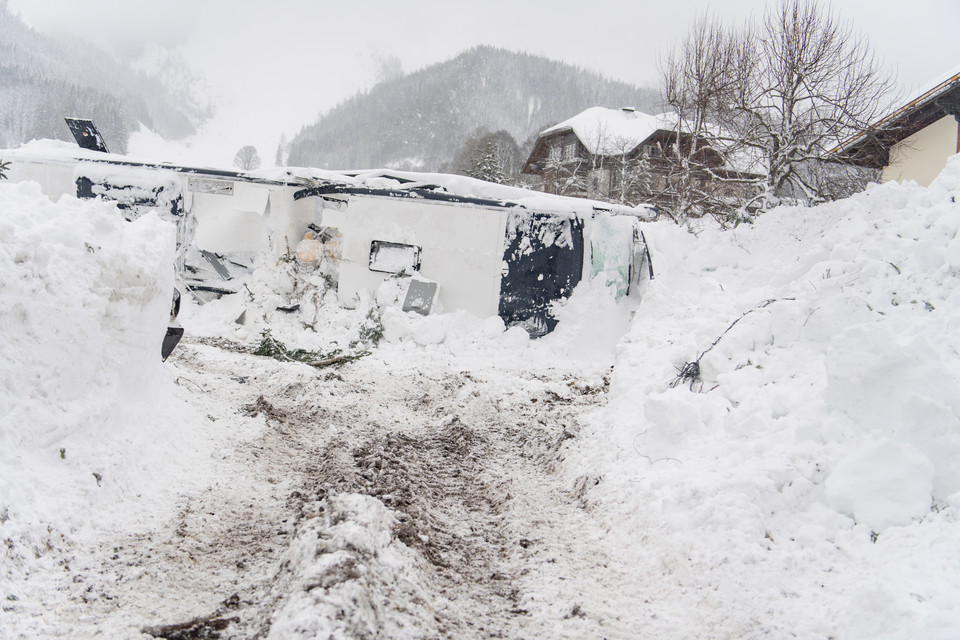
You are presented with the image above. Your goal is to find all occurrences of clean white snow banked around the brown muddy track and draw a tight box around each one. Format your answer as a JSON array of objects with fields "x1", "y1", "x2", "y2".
[{"x1": 0, "y1": 156, "x2": 960, "y2": 639}]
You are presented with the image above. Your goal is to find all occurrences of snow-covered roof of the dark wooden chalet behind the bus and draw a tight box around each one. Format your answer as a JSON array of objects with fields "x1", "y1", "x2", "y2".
[{"x1": 540, "y1": 107, "x2": 677, "y2": 156}]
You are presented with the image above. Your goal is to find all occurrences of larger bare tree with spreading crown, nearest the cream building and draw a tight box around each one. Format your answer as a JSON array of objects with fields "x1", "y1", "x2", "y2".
[{"x1": 734, "y1": 0, "x2": 892, "y2": 201}]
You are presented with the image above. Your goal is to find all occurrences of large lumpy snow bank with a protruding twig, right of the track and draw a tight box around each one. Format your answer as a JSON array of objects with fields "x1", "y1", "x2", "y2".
[{"x1": 568, "y1": 156, "x2": 960, "y2": 640}]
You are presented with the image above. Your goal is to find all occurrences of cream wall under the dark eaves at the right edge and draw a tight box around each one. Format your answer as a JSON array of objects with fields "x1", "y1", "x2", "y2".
[{"x1": 882, "y1": 116, "x2": 960, "y2": 186}]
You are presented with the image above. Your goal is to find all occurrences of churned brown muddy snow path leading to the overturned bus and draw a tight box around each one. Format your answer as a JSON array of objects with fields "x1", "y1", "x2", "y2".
[{"x1": 22, "y1": 343, "x2": 639, "y2": 639}]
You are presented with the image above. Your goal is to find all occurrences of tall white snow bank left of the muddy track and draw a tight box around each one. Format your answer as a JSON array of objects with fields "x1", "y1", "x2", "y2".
[{"x1": 0, "y1": 182, "x2": 211, "y2": 576}]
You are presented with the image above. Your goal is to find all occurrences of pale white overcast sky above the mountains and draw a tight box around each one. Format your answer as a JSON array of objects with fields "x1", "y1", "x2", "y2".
[{"x1": 8, "y1": 0, "x2": 960, "y2": 165}]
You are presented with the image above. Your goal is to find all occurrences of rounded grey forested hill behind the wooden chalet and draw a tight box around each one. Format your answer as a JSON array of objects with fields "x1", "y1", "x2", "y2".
[{"x1": 287, "y1": 47, "x2": 658, "y2": 171}]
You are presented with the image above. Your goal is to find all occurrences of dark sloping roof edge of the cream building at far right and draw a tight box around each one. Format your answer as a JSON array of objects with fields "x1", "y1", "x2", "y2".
[{"x1": 834, "y1": 65, "x2": 960, "y2": 169}]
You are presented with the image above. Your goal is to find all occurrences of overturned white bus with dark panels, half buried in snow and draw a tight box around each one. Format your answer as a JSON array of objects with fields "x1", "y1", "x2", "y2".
[{"x1": 0, "y1": 120, "x2": 655, "y2": 336}]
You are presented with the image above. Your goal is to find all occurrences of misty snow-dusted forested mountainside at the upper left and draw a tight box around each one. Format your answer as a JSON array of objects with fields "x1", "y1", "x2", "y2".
[{"x1": 0, "y1": 0, "x2": 203, "y2": 153}]
